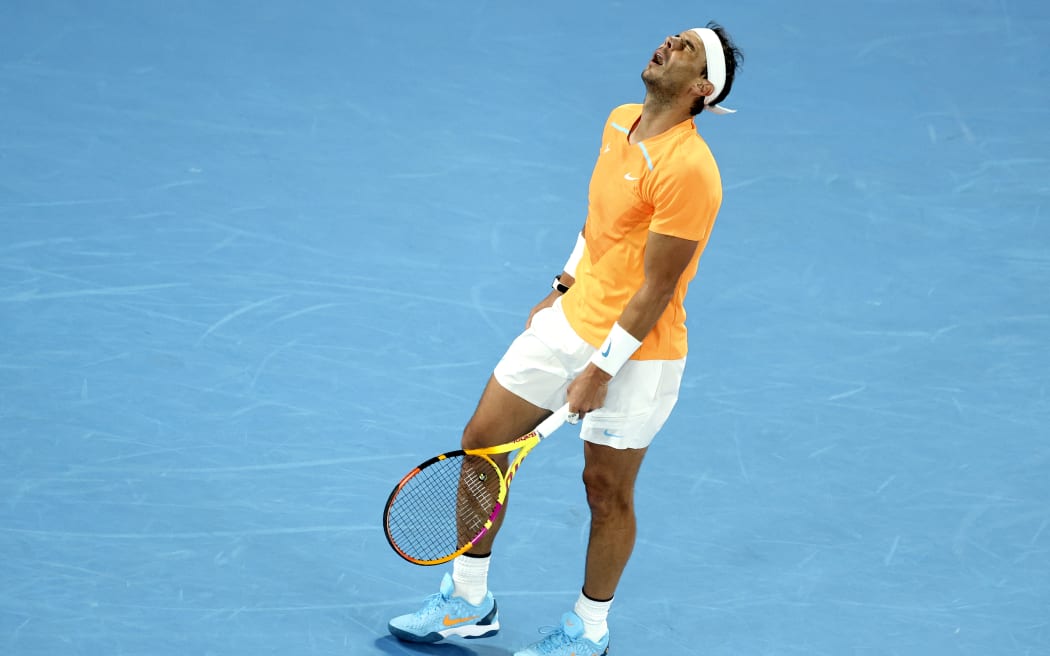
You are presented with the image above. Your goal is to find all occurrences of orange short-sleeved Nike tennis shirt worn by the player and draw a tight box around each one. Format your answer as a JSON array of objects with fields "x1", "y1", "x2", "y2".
[{"x1": 562, "y1": 105, "x2": 722, "y2": 360}]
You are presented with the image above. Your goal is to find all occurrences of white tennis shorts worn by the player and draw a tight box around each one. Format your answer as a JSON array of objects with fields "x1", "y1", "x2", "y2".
[{"x1": 495, "y1": 299, "x2": 686, "y2": 449}]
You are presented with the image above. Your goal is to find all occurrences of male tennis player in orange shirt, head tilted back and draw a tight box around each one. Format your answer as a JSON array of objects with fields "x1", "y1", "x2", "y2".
[{"x1": 390, "y1": 23, "x2": 741, "y2": 656}]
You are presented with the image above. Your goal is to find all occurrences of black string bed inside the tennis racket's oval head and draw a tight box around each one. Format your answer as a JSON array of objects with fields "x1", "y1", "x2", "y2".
[{"x1": 386, "y1": 453, "x2": 501, "y2": 560}]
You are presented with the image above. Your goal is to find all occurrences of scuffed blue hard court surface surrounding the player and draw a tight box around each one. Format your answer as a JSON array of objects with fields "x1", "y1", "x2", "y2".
[{"x1": 0, "y1": 0, "x2": 1050, "y2": 656}]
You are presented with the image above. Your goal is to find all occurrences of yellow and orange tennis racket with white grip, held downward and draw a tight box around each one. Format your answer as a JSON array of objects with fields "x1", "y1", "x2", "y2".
[{"x1": 383, "y1": 404, "x2": 569, "y2": 565}]
